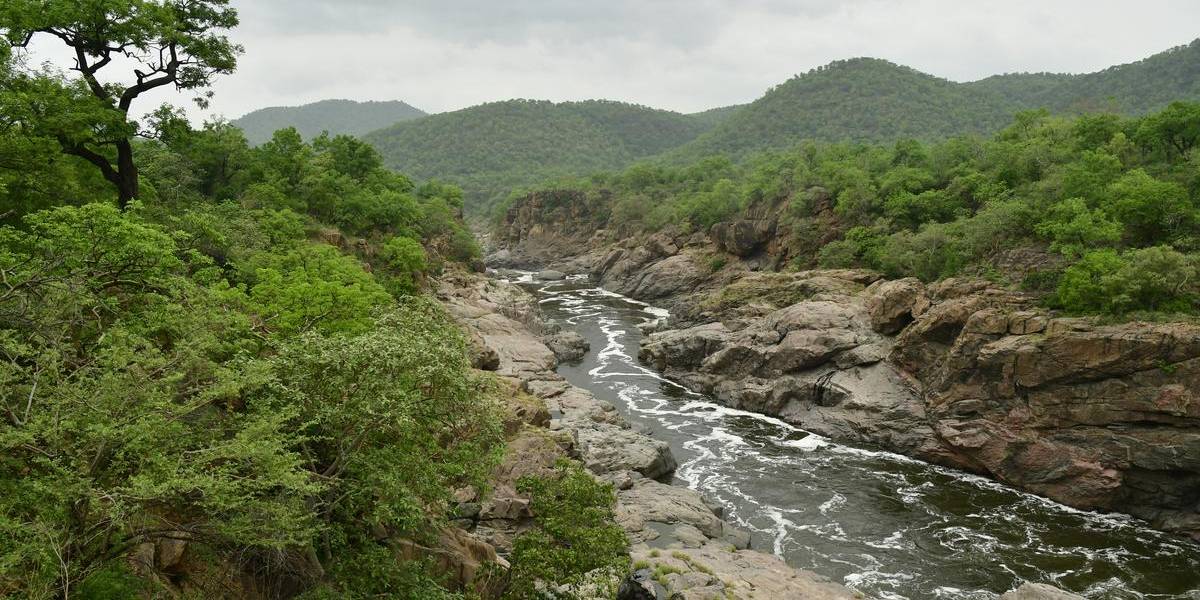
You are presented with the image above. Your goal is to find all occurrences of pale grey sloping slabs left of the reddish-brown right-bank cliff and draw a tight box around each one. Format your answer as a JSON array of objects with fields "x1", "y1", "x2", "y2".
[{"x1": 641, "y1": 272, "x2": 962, "y2": 466}]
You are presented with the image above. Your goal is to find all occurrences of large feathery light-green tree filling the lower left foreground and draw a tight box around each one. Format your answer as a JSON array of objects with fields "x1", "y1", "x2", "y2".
[{"x1": 0, "y1": 204, "x2": 322, "y2": 599}]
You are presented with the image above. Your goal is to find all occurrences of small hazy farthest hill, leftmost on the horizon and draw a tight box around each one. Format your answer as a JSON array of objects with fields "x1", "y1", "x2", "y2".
[{"x1": 233, "y1": 100, "x2": 425, "y2": 145}]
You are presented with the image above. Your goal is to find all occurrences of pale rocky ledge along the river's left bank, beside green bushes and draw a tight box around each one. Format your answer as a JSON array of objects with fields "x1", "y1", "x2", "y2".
[{"x1": 431, "y1": 276, "x2": 854, "y2": 600}]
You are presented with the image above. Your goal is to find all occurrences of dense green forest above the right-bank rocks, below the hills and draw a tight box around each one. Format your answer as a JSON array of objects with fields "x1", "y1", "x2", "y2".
[{"x1": 510, "y1": 102, "x2": 1200, "y2": 316}]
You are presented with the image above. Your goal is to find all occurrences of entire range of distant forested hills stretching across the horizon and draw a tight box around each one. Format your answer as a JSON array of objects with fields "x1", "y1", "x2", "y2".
[{"x1": 235, "y1": 40, "x2": 1200, "y2": 214}]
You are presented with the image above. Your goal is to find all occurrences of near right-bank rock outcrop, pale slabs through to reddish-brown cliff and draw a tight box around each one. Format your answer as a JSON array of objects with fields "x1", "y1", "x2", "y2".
[{"x1": 641, "y1": 270, "x2": 1200, "y2": 535}]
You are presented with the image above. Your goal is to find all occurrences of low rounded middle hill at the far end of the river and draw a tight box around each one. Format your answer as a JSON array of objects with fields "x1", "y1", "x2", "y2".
[{"x1": 365, "y1": 100, "x2": 713, "y2": 210}]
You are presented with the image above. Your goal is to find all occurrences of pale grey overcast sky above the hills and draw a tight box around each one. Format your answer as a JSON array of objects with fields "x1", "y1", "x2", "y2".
[{"x1": 21, "y1": 0, "x2": 1200, "y2": 118}]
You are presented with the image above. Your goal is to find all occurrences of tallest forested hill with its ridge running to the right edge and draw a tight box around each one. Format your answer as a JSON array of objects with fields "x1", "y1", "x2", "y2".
[{"x1": 670, "y1": 40, "x2": 1200, "y2": 161}]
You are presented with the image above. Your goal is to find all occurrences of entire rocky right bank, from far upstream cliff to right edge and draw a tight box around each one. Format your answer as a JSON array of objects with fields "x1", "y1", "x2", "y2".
[{"x1": 484, "y1": 195, "x2": 1200, "y2": 539}]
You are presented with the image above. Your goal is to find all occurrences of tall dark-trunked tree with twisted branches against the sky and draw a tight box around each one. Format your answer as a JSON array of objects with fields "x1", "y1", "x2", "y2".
[{"x1": 0, "y1": 0, "x2": 241, "y2": 209}]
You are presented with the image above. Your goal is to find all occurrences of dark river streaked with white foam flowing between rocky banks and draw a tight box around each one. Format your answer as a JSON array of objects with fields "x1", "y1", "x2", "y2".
[{"x1": 511, "y1": 276, "x2": 1200, "y2": 600}]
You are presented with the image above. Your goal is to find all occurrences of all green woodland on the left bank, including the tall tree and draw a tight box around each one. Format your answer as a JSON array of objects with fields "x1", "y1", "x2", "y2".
[{"x1": 0, "y1": 0, "x2": 628, "y2": 600}]
